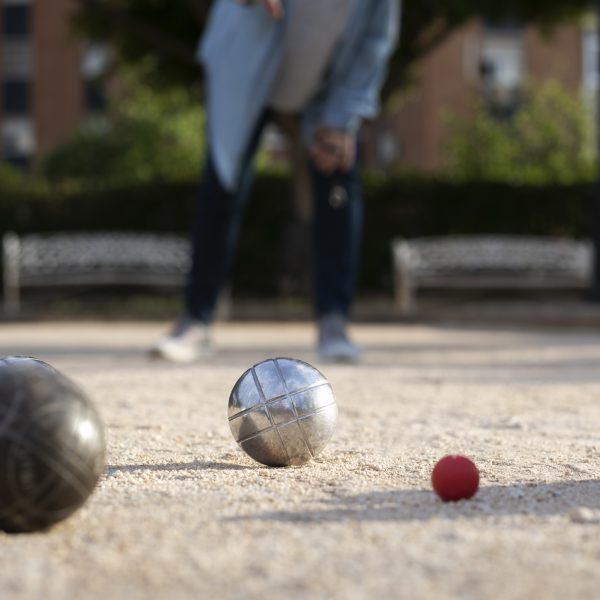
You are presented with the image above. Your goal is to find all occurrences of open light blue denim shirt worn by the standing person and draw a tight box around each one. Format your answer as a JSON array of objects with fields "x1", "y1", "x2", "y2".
[{"x1": 198, "y1": 0, "x2": 400, "y2": 190}]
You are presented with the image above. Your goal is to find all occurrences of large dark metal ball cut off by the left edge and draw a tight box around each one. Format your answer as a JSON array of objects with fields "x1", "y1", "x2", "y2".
[{"x1": 0, "y1": 356, "x2": 106, "y2": 532}]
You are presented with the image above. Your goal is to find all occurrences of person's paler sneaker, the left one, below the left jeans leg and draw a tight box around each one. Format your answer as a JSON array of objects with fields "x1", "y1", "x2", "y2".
[{"x1": 150, "y1": 318, "x2": 213, "y2": 363}]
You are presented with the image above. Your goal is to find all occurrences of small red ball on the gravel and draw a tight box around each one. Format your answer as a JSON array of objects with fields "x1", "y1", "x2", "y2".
[{"x1": 431, "y1": 454, "x2": 479, "y2": 502}]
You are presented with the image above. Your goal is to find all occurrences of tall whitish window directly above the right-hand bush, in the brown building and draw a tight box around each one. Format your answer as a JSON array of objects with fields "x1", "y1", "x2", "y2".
[{"x1": 480, "y1": 26, "x2": 525, "y2": 117}]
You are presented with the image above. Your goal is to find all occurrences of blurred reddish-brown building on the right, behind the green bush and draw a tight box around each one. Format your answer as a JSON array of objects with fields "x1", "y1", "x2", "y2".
[{"x1": 368, "y1": 20, "x2": 598, "y2": 172}]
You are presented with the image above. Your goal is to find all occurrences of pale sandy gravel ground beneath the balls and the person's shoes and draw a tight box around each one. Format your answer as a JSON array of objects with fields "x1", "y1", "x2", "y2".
[{"x1": 0, "y1": 322, "x2": 600, "y2": 600}]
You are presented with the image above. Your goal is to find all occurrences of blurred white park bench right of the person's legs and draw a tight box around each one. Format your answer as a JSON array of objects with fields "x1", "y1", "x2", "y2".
[{"x1": 392, "y1": 235, "x2": 594, "y2": 315}]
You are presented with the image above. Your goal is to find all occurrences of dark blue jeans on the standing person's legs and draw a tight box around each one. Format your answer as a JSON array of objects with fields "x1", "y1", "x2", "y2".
[{"x1": 185, "y1": 114, "x2": 363, "y2": 323}]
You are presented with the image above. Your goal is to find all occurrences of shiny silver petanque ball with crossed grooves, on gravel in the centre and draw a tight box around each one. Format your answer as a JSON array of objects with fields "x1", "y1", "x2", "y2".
[{"x1": 229, "y1": 358, "x2": 337, "y2": 467}]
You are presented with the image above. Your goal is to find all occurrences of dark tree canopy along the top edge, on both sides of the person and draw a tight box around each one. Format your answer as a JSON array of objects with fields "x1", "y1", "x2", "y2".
[{"x1": 76, "y1": 0, "x2": 593, "y2": 89}]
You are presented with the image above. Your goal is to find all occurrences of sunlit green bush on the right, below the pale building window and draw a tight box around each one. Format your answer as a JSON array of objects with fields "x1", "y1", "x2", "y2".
[{"x1": 448, "y1": 81, "x2": 595, "y2": 185}]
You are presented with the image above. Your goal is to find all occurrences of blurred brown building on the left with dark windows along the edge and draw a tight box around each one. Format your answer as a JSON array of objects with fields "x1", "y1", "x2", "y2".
[{"x1": 0, "y1": 0, "x2": 102, "y2": 165}]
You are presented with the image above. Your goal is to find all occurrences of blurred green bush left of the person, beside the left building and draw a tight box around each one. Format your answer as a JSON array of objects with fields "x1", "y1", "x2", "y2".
[{"x1": 42, "y1": 71, "x2": 204, "y2": 189}]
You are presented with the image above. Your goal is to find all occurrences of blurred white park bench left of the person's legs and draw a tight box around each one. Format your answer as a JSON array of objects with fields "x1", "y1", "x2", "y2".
[{"x1": 2, "y1": 232, "x2": 190, "y2": 316}]
